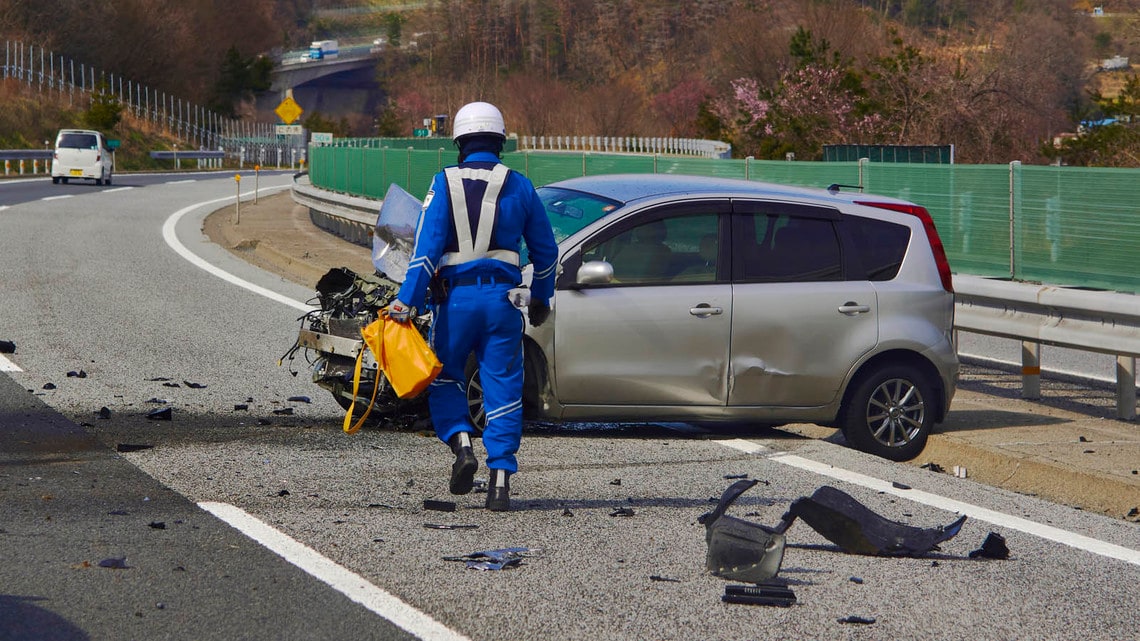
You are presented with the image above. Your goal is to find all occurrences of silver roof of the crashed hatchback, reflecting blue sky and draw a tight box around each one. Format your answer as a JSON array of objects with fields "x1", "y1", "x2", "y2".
[{"x1": 546, "y1": 173, "x2": 907, "y2": 204}]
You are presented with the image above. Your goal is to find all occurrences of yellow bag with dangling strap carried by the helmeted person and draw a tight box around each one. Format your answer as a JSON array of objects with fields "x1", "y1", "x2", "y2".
[{"x1": 344, "y1": 311, "x2": 443, "y2": 433}]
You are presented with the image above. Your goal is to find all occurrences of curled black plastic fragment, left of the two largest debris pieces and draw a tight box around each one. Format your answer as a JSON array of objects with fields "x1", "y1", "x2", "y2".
[{"x1": 700, "y1": 479, "x2": 784, "y2": 583}]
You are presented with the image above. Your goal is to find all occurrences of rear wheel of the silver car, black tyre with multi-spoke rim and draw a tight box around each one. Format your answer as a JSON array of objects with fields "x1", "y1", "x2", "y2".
[{"x1": 842, "y1": 365, "x2": 935, "y2": 461}]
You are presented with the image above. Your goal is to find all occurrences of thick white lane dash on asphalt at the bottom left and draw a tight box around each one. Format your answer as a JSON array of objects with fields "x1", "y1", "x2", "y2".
[{"x1": 198, "y1": 501, "x2": 467, "y2": 641}]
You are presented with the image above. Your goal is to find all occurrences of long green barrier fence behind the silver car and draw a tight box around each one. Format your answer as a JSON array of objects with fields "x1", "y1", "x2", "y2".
[{"x1": 309, "y1": 141, "x2": 1140, "y2": 293}]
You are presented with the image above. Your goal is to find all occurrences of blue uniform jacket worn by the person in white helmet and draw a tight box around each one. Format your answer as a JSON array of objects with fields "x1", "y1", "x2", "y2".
[{"x1": 399, "y1": 152, "x2": 559, "y2": 309}]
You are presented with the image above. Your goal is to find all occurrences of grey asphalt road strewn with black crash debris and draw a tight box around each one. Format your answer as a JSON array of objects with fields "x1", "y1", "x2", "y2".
[{"x1": 0, "y1": 175, "x2": 1140, "y2": 641}]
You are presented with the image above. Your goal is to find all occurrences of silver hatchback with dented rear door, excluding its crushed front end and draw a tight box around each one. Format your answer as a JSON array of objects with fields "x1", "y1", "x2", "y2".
[{"x1": 469, "y1": 175, "x2": 959, "y2": 461}]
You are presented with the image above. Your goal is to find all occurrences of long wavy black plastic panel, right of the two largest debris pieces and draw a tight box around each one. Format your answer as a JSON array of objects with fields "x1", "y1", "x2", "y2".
[{"x1": 780, "y1": 486, "x2": 966, "y2": 557}]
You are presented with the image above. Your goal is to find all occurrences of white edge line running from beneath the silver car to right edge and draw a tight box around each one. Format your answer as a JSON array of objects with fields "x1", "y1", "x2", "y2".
[{"x1": 717, "y1": 439, "x2": 1140, "y2": 566}]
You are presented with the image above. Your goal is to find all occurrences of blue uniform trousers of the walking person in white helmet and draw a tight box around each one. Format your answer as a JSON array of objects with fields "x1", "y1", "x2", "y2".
[{"x1": 428, "y1": 282, "x2": 523, "y2": 473}]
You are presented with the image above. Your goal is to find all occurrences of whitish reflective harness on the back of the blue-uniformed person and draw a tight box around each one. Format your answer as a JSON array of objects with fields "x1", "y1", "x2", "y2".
[{"x1": 440, "y1": 164, "x2": 519, "y2": 267}]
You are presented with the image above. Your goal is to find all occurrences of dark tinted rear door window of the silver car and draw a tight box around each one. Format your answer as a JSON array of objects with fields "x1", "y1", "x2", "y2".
[{"x1": 736, "y1": 213, "x2": 842, "y2": 283}]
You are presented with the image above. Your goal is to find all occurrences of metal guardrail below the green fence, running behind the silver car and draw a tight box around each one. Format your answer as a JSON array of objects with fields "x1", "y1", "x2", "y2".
[{"x1": 293, "y1": 175, "x2": 1140, "y2": 421}]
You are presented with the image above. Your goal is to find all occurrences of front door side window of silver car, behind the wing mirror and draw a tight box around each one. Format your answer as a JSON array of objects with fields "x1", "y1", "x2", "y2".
[{"x1": 583, "y1": 213, "x2": 719, "y2": 285}]
